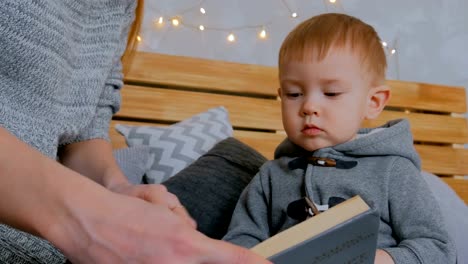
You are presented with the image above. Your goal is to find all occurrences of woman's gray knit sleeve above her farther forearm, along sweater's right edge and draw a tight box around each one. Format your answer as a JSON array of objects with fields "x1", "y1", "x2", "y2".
[{"x1": 75, "y1": 1, "x2": 136, "y2": 142}]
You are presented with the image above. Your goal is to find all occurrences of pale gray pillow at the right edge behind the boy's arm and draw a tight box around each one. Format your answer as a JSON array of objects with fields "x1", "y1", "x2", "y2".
[{"x1": 421, "y1": 171, "x2": 468, "y2": 263}]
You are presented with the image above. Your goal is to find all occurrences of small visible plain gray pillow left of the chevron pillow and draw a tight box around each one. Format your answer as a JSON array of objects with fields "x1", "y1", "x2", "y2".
[{"x1": 114, "y1": 146, "x2": 150, "y2": 184}]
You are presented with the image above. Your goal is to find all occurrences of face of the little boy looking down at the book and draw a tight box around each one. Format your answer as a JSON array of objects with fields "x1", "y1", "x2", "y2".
[{"x1": 278, "y1": 47, "x2": 370, "y2": 151}]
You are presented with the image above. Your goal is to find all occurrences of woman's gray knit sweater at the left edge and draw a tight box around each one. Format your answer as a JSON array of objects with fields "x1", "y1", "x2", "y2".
[{"x1": 0, "y1": 0, "x2": 136, "y2": 263}]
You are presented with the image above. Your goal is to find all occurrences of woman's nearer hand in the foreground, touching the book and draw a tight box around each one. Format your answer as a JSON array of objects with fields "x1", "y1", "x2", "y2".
[{"x1": 48, "y1": 186, "x2": 269, "y2": 264}]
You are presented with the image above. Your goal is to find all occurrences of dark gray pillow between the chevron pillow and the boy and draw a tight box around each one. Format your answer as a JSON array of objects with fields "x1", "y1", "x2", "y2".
[{"x1": 162, "y1": 137, "x2": 266, "y2": 239}]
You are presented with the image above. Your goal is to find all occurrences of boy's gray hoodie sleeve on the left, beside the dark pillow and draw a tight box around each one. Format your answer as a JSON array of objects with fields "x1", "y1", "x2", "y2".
[{"x1": 223, "y1": 166, "x2": 270, "y2": 248}]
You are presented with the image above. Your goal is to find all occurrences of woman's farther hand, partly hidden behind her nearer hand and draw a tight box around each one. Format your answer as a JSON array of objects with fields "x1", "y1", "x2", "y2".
[{"x1": 109, "y1": 182, "x2": 197, "y2": 228}]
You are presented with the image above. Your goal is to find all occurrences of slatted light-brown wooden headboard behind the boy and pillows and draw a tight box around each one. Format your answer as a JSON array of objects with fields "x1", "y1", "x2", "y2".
[{"x1": 110, "y1": 52, "x2": 468, "y2": 203}]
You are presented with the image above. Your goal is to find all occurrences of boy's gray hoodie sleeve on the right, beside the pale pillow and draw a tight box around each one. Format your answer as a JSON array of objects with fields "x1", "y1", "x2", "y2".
[{"x1": 383, "y1": 159, "x2": 456, "y2": 263}]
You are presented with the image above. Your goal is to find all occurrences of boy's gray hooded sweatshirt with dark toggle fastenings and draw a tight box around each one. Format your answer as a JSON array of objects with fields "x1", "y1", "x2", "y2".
[{"x1": 223, "y1": 120, "x2": 456, "y2": 264}]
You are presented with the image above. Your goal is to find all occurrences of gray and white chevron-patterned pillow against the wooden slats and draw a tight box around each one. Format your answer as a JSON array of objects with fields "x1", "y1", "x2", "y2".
[{"x1": 116, "y1": 106, "x2": 232, "y2": 183}]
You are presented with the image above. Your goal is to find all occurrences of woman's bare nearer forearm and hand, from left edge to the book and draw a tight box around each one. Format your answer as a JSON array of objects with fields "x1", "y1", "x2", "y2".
[{"x1": 0, "y1": 127, "x2": 267, "y2": 264}]
